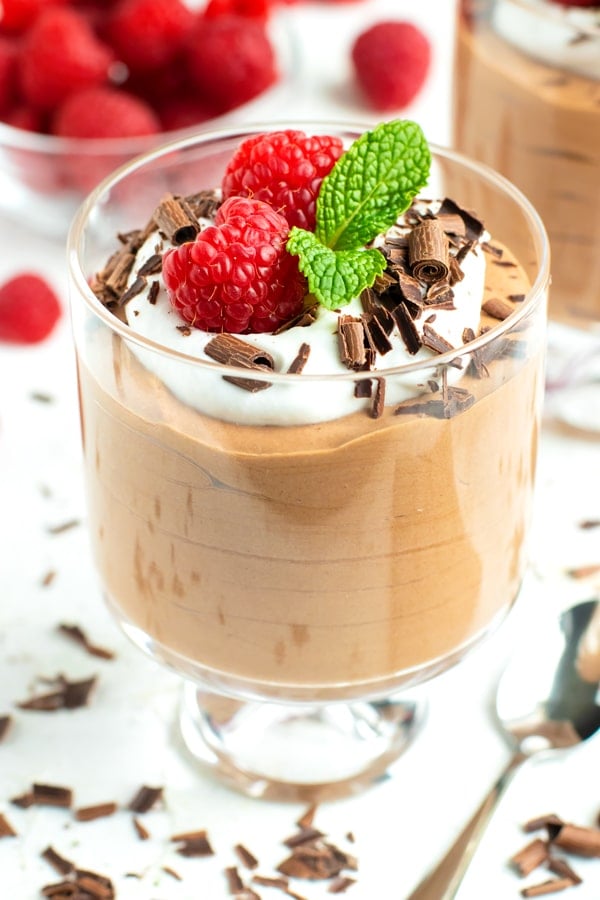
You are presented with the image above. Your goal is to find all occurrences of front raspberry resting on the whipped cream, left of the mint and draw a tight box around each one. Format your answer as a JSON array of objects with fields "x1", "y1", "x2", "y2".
[{"x1": 163, "y1": 197, "x2": 306, "y2": 334}]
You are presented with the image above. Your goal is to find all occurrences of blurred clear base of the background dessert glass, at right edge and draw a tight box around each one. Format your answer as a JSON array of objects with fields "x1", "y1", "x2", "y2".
[{"x1": 546, "y1": 322, "x2": 600, "y2": 437}]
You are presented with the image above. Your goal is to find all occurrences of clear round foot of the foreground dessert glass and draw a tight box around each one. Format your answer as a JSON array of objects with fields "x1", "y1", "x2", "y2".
[{"x1": 180, "y1": 682, "x2": 425, "y2": 803}]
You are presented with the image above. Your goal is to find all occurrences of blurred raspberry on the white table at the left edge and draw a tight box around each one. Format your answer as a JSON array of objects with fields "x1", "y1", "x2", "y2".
[{"x1": 0, "y1": 272, "x2": 61, "y2": 344}]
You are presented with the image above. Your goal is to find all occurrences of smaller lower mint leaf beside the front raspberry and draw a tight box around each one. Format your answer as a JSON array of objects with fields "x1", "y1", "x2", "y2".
[{"x1": 287, "y1": 227, "x2": 386, "y2": 309}]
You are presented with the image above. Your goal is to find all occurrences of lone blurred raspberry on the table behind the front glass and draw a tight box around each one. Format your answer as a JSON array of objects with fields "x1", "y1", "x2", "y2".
[{"x1": 352, "y1": 22, "x2": 431, "y2": 110}]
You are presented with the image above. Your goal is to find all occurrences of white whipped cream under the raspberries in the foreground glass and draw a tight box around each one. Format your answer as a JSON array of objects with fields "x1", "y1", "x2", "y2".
[{"x1": 119, "y1": 206, "x2": 487, "y2": 425}]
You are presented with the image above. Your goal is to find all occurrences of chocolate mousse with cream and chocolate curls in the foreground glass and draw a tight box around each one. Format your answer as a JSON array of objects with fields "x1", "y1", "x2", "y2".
[{"x1": 71, "y1": 125, "x2": 544, "y2": 699}]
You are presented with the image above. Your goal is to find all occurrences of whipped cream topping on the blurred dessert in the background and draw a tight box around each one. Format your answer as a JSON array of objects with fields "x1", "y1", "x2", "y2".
[{"x1": 492, "y1": 0, "x2": 600, "y2": 80}]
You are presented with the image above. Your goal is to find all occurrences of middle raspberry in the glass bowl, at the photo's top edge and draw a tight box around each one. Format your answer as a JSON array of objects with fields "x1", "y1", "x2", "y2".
[{"x1": 106, "y1": 0, "x2": 196, "y2": 72}]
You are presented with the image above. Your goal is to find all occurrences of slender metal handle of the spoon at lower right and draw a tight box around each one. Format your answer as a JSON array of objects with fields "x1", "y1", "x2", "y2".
[{"x1": 408, "y1": 752, "x2": 527, "y2": 900}]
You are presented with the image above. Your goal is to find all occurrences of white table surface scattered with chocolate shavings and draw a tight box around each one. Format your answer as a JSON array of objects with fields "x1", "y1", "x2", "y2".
[{"x1": 0, "y1": 0, "x2": 600, "y2": 900}]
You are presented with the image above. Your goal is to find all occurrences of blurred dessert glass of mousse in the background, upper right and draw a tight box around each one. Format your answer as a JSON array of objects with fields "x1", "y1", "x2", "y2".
[{"x1": 453, "y1": 0, "x2": 600, "y2": 434}]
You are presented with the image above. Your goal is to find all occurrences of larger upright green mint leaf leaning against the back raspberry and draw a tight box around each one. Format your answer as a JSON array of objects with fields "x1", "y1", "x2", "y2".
[{"x1": 316, "y1": 119, "x2": 431, "y2": 250}]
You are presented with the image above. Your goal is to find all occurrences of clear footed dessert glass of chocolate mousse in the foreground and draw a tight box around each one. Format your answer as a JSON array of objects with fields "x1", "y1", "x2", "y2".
[{"x1": 68, "y1": 123, "x2": 549, "y2": 799}]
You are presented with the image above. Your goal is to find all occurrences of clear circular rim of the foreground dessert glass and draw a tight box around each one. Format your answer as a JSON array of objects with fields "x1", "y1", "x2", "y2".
[{"x1": 67, "y1": 119, "x2": 550, "y2": 384}]
